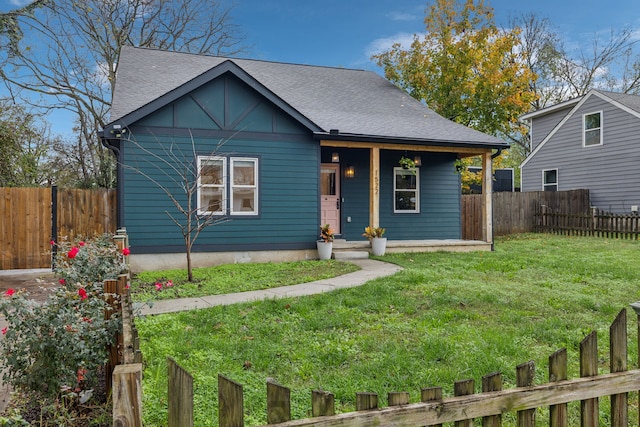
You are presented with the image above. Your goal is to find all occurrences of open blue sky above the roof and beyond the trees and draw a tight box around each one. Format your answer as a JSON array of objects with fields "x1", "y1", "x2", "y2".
[{"x1": 0, "y1": 0, "x2": 640, "y2": 134}]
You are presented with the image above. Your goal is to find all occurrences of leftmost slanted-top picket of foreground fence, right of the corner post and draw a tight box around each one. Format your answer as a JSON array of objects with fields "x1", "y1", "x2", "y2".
[{"x1": 167, "y1": 357, "x2": 193, "y2": 427}]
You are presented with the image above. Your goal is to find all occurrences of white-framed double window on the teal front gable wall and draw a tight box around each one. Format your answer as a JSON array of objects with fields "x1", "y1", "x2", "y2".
[{"x1": 198, "y1": 156, "x2": 258, "y2": 215}]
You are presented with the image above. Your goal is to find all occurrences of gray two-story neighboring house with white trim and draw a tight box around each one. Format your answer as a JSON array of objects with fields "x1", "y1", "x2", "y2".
[{"x1": 520, "y1": 90, "x2": 640, "y2": 213}]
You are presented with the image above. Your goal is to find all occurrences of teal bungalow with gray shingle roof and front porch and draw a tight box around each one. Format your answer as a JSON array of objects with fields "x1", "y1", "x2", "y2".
[{"x1": 102, "y1": 47, "x2": 508, "y2": 268}]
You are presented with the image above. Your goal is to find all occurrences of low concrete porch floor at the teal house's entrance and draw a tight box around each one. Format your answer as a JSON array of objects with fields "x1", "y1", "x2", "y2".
[{"x1": 333, "y1": 239, "x2": 491, "y2": 253}]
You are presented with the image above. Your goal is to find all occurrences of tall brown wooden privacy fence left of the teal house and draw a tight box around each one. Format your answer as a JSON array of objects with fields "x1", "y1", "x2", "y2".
[{"x1": 0, "y1": 187, "x2": 116, "y2": 270}]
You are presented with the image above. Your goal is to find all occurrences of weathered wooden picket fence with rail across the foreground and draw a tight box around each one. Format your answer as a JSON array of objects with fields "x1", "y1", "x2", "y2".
[{"x1": 158, "y1": 307, "x2": 640, "y2": 427}]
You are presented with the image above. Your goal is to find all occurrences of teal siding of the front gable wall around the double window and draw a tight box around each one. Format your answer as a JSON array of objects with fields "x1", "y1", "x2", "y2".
[{"x1": 122, "y1": 72, "x2": 320, "y2": 253}]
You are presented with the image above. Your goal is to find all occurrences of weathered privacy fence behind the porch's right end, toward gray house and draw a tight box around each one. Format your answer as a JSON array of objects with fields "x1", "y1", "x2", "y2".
[{"x1": 462, "y1": 190, "x2": 590, "y2": 240}]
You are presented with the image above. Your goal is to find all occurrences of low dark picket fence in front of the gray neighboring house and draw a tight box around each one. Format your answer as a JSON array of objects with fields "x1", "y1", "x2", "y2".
[{"x1": 534, "y1": 206, "x2": 640, "y2": 240}]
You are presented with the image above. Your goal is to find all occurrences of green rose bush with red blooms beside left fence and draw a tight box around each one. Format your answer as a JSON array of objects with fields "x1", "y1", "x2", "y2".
[{"x1": 0, "y1": 236, "x2": 124, "y2": 398}]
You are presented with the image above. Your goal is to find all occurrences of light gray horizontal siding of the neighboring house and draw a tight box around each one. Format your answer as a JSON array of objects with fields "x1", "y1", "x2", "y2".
[{"x1": 522, "y1": 96, "x2": 640, "y2": 213}]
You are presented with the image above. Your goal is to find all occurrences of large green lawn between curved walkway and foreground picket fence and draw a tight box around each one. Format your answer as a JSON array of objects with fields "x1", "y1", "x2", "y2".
[{"x1": 137, "y1": 235, "x2": 640, "y2": 426}]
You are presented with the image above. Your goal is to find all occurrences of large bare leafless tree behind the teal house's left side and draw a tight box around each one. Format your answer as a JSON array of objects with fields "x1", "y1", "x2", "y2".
[{"x1": 0, "y1": 0, "x2": 243, "y2": 186}]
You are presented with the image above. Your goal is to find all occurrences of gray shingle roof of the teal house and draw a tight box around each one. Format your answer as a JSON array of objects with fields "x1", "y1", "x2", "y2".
[{"x1": 111, "y1": 47, "x2": 508, "y2": 148}]
